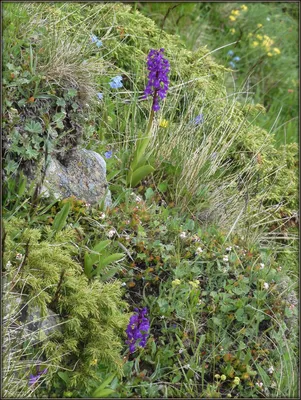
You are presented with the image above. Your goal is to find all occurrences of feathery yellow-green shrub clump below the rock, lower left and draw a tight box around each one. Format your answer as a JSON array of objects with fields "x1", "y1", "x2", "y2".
[{"x1": 4, "y1": 218, "x2": 129, "y2": 396}]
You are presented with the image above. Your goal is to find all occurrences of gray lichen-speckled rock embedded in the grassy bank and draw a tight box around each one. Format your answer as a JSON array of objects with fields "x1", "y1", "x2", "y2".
[{"x1": 40, "y1": 149, "x2": 112, "y2": 207}]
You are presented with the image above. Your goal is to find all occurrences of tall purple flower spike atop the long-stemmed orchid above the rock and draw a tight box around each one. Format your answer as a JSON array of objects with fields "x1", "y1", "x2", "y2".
[{"x1": 144, "y1": 49, "x2": 170, "y2": 111}]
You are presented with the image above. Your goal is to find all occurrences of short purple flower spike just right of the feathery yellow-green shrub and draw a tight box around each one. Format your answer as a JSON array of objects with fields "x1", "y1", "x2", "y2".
[{"x1": 126, "y1": 307, "x2": 149, "y2": 353}]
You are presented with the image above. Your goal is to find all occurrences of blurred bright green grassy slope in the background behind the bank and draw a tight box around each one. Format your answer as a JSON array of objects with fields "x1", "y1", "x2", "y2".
[{"x1": 140, "y1": 3, "x2": 299, "y2": 143}]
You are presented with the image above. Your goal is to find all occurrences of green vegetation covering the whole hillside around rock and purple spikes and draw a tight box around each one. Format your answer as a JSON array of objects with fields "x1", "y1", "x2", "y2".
[{"x1": 2, "y1": 3, "x2": 298, "y2": 398}]
